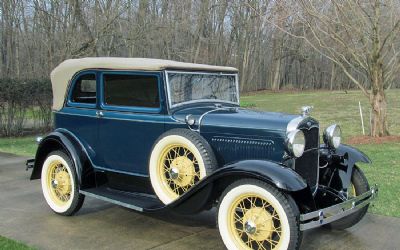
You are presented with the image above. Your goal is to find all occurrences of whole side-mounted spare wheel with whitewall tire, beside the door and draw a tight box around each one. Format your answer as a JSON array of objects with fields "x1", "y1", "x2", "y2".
[{"x1": 149, "y1": 129, "x2": 217, "y2": 204}]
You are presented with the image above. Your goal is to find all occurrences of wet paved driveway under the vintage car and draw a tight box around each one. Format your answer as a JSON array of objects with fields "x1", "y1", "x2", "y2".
[{"x1": 0, "y1": 153, "x2": 400, "y2": 250}]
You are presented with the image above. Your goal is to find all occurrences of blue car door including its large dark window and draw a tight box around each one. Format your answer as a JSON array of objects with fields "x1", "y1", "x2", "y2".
[{"x1": 99, "y1": 71, "x2": 165, "y2": 176}]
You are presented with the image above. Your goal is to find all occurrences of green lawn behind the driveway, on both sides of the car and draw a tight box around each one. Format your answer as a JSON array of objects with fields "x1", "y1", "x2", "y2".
[{"x1": 0, "y1": 90, "x2": 400, "y2": 221}]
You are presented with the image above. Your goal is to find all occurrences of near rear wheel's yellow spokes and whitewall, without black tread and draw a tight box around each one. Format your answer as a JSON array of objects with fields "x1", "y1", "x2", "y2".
[{"x1": 41, "y1": 151, "x2": 76, "y2": 213}]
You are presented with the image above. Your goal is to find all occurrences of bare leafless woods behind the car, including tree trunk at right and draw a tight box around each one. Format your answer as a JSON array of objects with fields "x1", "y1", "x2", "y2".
[{"x1": 0, "y1": 0, "x2": 400, "y2": 136}]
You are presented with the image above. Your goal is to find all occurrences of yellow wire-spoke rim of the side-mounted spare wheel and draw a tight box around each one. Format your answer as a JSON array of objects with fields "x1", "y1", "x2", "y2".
[{"x1": 158, "y1": 144, "x2": 201, "y2": 198}]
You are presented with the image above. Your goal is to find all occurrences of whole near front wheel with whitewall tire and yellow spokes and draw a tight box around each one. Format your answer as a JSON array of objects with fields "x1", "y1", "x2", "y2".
[{"x1": 217, "y1": 179, "x2": 301, "y2": 250}]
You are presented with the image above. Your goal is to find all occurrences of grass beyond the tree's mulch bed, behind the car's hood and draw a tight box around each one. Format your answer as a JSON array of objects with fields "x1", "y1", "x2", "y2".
[{"x1": 241, "y1": 89, "x2": 400, "y2": 139}]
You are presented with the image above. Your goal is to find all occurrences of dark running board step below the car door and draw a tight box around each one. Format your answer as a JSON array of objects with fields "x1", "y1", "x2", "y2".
[{"x1": 79, "y1": 186, "x2": 165, "y2": 212}]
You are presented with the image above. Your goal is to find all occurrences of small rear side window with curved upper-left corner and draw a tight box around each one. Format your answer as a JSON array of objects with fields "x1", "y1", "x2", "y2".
[{"x1": 71, "y1": 74, "x2": 96, "y2": 104}]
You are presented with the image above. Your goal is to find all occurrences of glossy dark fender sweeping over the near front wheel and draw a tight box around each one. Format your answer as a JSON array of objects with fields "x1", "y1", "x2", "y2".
[{"x1": 168, "y1": 160, "x2": 308, "y2": 213}]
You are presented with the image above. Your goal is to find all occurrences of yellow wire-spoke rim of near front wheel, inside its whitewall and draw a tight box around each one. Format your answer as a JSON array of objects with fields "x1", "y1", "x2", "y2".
[{"x1": 228, "y1": 193, "x2": 282, "y2": 249}]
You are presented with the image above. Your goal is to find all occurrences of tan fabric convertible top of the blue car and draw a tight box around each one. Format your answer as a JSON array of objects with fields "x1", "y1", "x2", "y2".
[{"x1": 50, "y1": 57, "x2": 238, "y2": 110}]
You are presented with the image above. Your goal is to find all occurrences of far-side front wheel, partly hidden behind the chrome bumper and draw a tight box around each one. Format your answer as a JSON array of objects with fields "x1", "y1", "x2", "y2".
[{"x1": 325, "y1": 166, "x2": 369, "y2": 230}]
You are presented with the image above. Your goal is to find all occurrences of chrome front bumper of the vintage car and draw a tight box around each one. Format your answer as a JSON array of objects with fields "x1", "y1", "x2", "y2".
[{"x1": 300, "y1": 185, "x2": 378, "y2": 231}]
